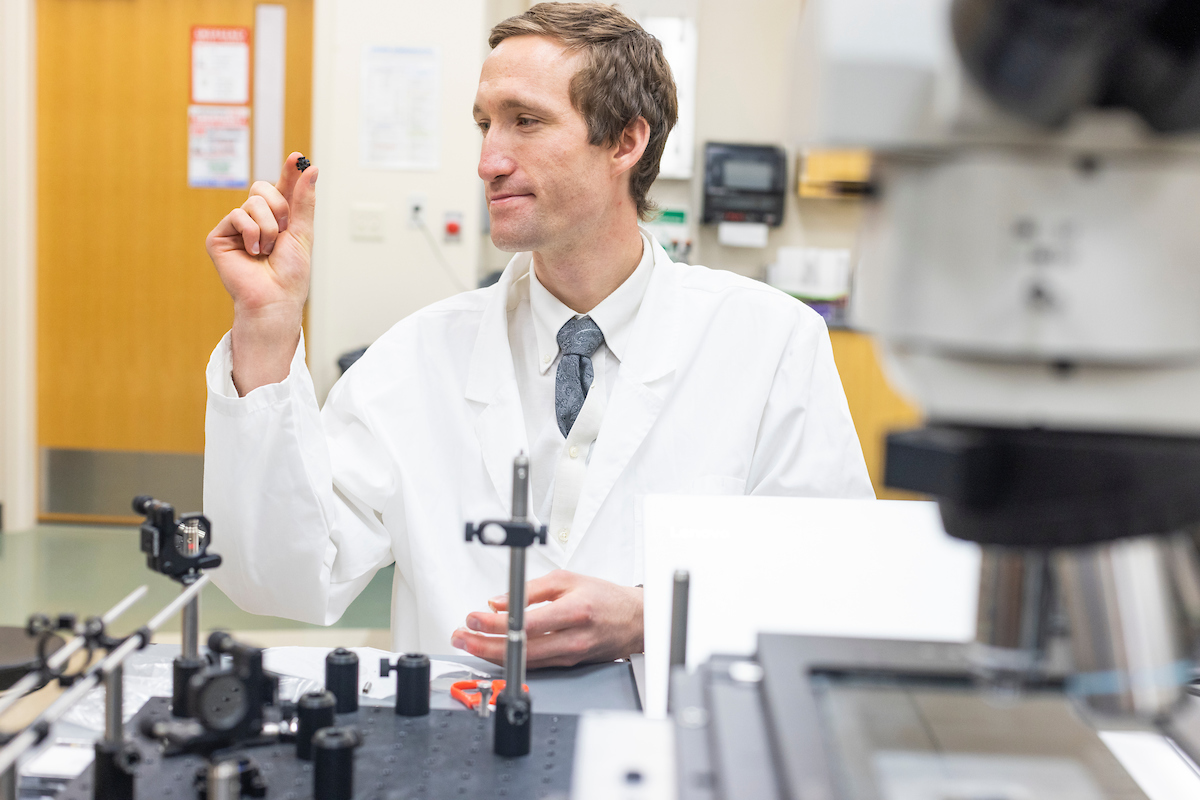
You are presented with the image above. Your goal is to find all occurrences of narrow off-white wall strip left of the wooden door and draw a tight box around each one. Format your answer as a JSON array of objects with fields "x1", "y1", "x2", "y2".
[{"x1": 0, "y1": 0, "x2": 37, "y2": 530}]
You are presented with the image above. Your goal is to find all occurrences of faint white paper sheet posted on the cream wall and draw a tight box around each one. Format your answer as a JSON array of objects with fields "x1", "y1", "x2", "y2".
[{"x1": 359, "y1": 47, "x2": 442, "y2": 170}]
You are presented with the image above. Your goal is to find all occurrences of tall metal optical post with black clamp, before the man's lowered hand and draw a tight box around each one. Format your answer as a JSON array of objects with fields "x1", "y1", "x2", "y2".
[{"x1": 467, "y1": 453, "x2": 547, "y2": 756}]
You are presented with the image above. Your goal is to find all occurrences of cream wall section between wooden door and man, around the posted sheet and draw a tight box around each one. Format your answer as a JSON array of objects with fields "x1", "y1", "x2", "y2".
[{"x1": 308, "y1": 0, "x2": 485, "y2": 398}]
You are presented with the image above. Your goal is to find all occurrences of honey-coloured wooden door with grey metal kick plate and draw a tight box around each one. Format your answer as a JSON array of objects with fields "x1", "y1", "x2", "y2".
[{"x1": 37, "y1": 0, "x2": 312, "y2": 521}]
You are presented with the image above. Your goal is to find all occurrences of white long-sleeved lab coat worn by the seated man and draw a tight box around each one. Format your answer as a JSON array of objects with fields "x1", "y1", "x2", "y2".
[{"x1": 204, "y1": 236, "x2": 874, "y2": 652}]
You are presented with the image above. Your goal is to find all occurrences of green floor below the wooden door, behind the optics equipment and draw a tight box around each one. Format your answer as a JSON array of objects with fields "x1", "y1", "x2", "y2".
[{"x1": 0, "y1": 525, "x2": 392, "y2": 633}]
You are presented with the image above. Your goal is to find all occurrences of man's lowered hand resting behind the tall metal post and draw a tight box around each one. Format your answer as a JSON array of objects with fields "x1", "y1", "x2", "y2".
[{"x1": 450, "y1": 570, "x2": 642, "y2": 669}]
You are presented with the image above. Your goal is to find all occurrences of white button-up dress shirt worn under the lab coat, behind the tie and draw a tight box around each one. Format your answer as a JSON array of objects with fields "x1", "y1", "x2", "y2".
[{"x1": 508, "y1": 232, "x2": 654, "y2": 545}]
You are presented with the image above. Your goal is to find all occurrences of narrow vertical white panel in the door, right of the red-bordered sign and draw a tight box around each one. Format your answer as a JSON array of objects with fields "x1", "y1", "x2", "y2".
[{"x1": 251, "y1": 4, "x2": 288, "y2": 184}]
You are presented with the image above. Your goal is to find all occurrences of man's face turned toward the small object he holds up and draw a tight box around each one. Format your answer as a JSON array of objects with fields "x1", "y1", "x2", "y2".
[{"x1": 474, "y1": 36, "x2": 619, "y2": 252}]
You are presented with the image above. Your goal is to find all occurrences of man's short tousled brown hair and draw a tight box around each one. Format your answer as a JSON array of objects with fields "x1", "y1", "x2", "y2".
[{"x1": 487, "y1": 2, "x2": 679, "y2": 219}]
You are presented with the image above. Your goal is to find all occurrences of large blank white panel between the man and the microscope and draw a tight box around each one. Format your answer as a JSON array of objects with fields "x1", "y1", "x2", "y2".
[{"x1": 642, "y1": 495, "x2": 979, "y2": 715}]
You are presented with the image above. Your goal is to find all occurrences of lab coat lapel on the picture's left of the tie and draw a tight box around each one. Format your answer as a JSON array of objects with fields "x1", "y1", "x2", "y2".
[{"x1": 466, "y1": 253, "x2": 529, "y2": 520}]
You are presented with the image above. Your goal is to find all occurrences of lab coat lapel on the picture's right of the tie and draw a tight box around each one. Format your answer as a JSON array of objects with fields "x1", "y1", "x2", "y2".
[{"x1": 569, "y1": 242, "x2": 679, "y2": 552}]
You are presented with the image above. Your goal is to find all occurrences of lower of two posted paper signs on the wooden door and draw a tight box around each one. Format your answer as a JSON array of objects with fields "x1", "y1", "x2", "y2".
[{"x1": 187, "y1": 106, "x2": 250, "y2": 188}]
